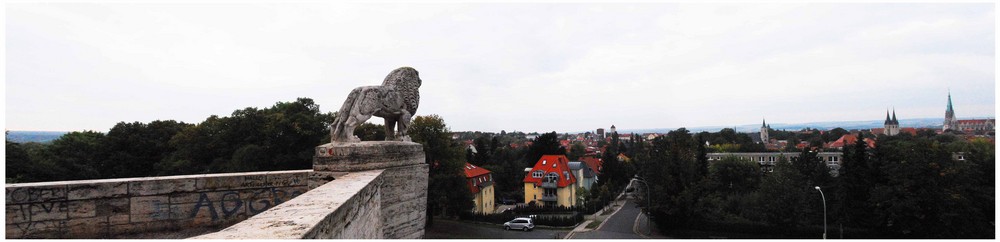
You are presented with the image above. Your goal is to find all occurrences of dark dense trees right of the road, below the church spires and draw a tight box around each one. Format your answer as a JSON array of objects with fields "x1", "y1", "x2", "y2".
[{"x1": 631, "y1": 129, "x2": 995, "y2": 238}]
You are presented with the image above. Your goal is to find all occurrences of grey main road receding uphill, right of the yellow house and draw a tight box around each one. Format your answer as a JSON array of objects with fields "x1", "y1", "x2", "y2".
[{"x1": 571, "y1": 199, "x2": 643, "y2": 239}]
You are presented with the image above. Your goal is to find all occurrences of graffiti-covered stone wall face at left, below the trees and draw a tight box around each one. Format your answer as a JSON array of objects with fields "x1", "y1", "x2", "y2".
[{"x1": 5, "y1": 170, "x2": 312, "y2": 239}]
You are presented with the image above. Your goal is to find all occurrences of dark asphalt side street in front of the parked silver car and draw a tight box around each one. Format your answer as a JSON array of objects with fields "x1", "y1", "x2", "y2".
[{"x1": 424, "y1": 216, "x2": 576, "y2": 239}]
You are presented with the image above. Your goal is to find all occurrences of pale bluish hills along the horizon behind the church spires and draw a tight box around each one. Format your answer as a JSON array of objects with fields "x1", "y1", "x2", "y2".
[{"x1": 608, "y1": 117, "x2": 992, "y2": 134}]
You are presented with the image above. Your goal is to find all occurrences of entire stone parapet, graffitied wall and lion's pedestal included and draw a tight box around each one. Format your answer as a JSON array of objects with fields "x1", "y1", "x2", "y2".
[{"x1": 6, "y1": 142, "x2": 429, "y2": 239}]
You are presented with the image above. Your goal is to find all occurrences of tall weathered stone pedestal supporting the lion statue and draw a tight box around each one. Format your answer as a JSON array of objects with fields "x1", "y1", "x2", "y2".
[{"x1": 309, "y1": 141, "x2": 428, "y2": 239}]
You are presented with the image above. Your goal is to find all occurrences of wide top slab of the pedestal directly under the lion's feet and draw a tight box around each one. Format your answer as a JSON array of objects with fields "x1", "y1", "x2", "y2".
[{"x1": 313, "y1": 141, "x2": 424, "y2": 172}]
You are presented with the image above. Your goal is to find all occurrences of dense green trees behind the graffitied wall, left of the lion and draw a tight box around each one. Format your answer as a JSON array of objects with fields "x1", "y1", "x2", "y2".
[{"x1": 6, "y1": 98, "x2": 333, "y2": 182}]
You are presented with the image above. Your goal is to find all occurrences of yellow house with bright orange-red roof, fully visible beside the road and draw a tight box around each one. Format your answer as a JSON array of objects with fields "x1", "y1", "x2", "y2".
[{"x1": 524, "y1": 155, "x2": 577, "y2": 207}]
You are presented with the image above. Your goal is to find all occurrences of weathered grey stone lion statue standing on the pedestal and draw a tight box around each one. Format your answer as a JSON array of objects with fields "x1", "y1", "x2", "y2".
[{"x1": 330, "y1": 67, "x2": 422, "y2": 142}]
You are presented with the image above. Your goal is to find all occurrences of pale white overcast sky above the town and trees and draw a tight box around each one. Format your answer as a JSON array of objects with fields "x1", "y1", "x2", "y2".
[{"x1": 5, "y1": 2, "x2": 996, "y2": 132}]
